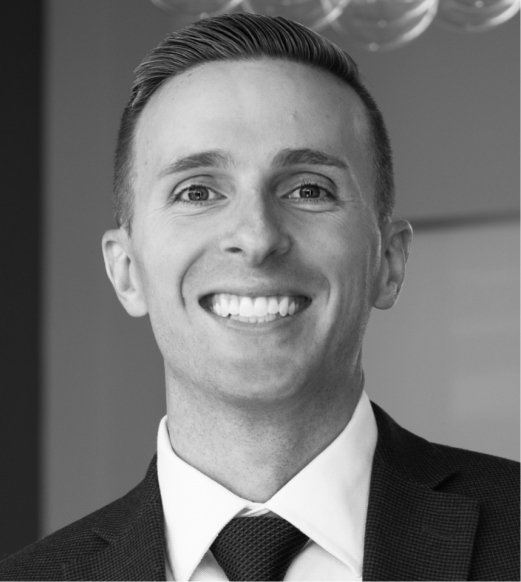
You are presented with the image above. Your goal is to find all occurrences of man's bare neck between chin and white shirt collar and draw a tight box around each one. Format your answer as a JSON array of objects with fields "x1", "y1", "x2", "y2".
[{"x1": 167, "y1": 365, "x2": 363, "y2": 503}]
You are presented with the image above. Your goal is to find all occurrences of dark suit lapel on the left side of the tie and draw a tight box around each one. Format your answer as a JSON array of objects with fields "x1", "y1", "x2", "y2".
[{"x1": 63, "y1": 457, "x2": 165, "y2": 580}]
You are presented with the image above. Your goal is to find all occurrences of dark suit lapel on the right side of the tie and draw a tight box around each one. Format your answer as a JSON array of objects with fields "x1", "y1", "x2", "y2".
[{"x1": 363, "y1": 404, "x2": 479, "y2": 580}]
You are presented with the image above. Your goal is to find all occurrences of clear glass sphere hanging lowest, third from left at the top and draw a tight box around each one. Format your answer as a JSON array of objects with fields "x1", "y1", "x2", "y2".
[{"x1": 331, "y1": 0, "x2": 438, "y2": 51}]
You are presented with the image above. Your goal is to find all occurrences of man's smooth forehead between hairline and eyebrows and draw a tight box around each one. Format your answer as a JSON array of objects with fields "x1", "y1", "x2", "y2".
[{"x1": 134, "y1": 59, "x2": 369, "y2": 187}]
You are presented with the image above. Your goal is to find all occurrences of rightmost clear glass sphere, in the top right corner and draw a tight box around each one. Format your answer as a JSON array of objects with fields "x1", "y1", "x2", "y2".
[{"x1": 437, "y1": 0, "x2": 520, "y2": 32}]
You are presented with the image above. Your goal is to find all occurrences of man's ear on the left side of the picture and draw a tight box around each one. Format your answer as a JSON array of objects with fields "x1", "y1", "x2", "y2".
[{"x1": 102, "y1": 228, "x2": 148, "y2": 317}]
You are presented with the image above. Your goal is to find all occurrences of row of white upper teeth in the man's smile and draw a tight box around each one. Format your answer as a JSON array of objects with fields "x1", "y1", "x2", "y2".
[{"x1": 210, "y1": 293, "x2": 302, "y2": 319}]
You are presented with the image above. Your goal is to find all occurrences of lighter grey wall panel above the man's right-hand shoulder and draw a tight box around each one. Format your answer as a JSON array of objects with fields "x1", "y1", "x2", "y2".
[{"x1": 364, "y1": 221, "x2": 519, "y2": 460}]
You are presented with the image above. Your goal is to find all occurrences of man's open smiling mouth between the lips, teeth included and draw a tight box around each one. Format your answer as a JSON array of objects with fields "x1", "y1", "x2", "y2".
[{"x1": 201, "y1": 293, "x2": 311, "y2": 323}]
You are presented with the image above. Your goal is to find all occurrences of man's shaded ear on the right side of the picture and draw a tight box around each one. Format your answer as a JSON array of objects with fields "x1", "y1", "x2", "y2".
[{"x1": 373, "y1": 220, "x2": 412, "y2": 309}]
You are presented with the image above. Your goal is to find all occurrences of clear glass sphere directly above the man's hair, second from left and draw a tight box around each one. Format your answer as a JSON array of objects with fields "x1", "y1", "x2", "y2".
[{"x1": 242, "y1": 0, "x2": 350, "y2": 30}]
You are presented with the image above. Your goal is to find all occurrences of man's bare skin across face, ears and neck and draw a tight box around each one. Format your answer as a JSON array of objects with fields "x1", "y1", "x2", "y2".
[{"x1": 103, "y1": 59, "x2": 412, "y2": 502}]
